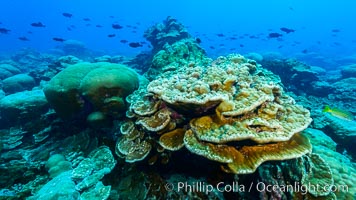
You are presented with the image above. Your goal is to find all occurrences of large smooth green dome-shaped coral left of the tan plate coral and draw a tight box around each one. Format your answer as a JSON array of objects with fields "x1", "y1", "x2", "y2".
[{"x1": 44, "y1": 62, "x2": 138, "y2": 119}]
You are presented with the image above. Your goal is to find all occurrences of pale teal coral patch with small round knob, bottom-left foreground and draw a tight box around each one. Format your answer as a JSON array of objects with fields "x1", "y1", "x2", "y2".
[{"x1": 29, "y1": 146, "x2": 116, "y2": 199}]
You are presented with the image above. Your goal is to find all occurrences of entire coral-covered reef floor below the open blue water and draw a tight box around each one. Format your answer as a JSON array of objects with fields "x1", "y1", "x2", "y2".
[{"x1": 0, "y1": 18, "x2": 356, "y2": 200}]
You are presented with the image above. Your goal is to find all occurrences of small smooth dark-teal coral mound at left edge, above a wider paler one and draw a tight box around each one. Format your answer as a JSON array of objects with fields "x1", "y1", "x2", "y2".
[{"x1": 2, "y1": 74, "x2": 35, "y2": 94}]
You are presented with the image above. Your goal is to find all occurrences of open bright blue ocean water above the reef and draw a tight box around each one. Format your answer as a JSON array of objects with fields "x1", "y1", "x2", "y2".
[{"x1": 0, "y1": 0, "x2": 356, "y2": 64}]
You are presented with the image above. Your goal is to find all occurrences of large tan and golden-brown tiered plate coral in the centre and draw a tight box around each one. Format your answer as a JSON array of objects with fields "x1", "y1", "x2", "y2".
[{"x1": 117, "y1": 51, "x2": 311, "y2": 174}]
